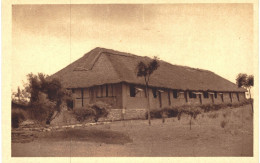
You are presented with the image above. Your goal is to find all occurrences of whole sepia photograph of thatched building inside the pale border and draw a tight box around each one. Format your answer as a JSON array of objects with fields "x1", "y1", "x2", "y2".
[{"x1": 2, "y1": 2, "x2": 258, "y2": 161}]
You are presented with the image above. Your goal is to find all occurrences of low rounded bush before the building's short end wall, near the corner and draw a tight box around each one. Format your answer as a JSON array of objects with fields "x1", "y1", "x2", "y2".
[{"x1": 73, "y1": 102, "x2": 111, "y2": 122}]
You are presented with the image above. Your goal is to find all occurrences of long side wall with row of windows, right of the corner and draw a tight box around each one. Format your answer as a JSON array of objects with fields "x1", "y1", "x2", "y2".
[{"x1": 123, "y1": 83, "x2": 245, "y2": 109}]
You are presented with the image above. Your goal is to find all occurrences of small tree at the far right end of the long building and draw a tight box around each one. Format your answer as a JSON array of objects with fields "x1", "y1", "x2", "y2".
[{"x1": 236, "y1": 73, "x2": 254, "y2": 112}]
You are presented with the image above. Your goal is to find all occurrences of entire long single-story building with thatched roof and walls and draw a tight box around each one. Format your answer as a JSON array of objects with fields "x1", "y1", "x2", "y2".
[{"x1": 52, "y1": 48, "x2": 246, "y2": 118}]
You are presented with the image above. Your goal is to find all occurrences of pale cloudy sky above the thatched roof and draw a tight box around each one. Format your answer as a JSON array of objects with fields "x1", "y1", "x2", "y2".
[{"x1": 12, "y1": 4, "x2": 254, "y2": 90}]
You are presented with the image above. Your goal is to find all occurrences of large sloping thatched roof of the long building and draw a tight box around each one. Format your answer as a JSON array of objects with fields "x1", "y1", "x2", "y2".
[{"x1": 51, "y1": 48, "x2": 246, "y2": 92}]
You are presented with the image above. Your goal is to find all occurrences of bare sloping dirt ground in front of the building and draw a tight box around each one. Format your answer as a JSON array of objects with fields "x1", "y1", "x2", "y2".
[{"x1": 12, "y1": 105, "x2": 253, "y2": 157}]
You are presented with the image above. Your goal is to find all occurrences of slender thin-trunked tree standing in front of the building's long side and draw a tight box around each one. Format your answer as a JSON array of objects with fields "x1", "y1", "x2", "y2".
[{"x1": 136, "y1": 57, "x2": 160, "y2": 125}]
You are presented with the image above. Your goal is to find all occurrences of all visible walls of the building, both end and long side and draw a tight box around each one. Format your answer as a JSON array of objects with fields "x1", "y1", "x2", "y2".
[{"x1": 71, "y1": 83, "x2": 245, "y2": 120}]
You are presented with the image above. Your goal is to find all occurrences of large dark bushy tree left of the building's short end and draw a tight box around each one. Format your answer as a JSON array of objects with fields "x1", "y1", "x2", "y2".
[{"x1": 12, "y1": 73, "x2": 71, "y2": 124}]
